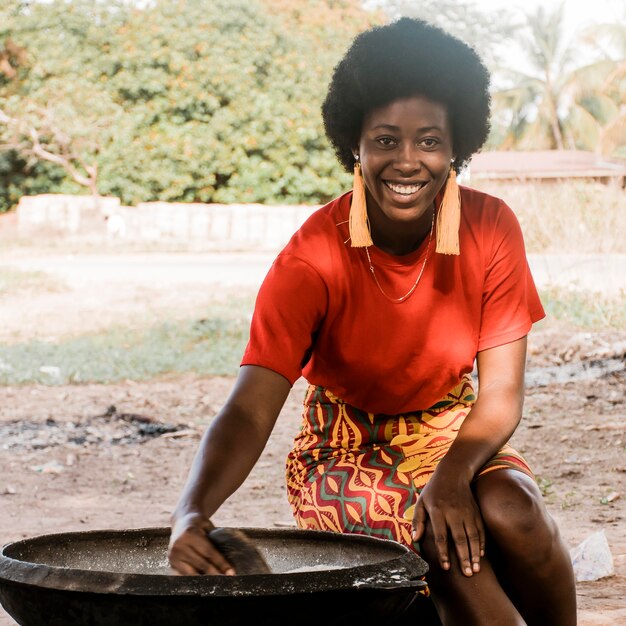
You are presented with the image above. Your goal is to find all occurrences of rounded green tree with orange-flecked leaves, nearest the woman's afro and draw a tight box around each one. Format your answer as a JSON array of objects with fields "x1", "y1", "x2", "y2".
[{"x1": 98, "y1": 0, "x2": 346, "y2": 202}]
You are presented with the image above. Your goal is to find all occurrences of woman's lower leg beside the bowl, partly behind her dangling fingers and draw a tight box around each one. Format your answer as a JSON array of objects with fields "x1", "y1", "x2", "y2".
[{"x1": 420, "y1": 525, "x2": 525, "y2": 626}]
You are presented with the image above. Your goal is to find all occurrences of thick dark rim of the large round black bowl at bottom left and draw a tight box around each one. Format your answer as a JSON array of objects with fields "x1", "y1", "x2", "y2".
[{"x1": 0, "y1": 527, "x2": 428, "y2": 597}]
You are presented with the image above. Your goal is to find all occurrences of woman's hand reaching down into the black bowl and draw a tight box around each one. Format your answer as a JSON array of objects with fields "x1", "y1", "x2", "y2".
[{"x1": 167, "y1": 514, "x2": 236, "y2": 576}]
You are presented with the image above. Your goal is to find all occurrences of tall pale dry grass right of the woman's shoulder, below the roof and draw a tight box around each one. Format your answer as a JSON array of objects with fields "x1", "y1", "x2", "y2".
[{"x1": 472, "y1": 181, "x2": 626, "y2": 254}]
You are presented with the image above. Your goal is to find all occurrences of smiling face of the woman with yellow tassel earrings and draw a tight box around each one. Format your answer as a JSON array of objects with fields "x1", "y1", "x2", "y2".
[{"x1": 358, "y1": 96, "x2": 453, "y2": 235}]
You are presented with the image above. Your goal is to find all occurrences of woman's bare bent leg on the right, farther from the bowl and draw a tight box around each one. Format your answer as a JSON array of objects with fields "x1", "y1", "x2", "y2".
[{"x1": 475, "y1": 469, "x2": 576, "y2": 626}]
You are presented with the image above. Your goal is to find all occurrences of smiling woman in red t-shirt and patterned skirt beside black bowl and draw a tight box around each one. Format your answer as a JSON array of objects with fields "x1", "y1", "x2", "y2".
[{"x1": 169, "y1": 18, "x2": 576, "y2": 626}]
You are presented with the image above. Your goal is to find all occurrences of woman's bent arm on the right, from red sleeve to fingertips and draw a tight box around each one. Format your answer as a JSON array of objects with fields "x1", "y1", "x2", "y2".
[{"x1": 413, "y1": 337, "x2": 526, "y2": 576}]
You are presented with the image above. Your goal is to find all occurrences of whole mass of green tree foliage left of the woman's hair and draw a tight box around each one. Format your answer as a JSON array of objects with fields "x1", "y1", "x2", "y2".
[{"x1": 0, "y1": 0, "x2": 375, "y2": 208}]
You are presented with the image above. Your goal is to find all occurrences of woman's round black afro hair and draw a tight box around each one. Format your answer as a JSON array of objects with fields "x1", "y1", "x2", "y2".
[{"x1": 322, "y1": 17, "x2": 490, "y2": 172}]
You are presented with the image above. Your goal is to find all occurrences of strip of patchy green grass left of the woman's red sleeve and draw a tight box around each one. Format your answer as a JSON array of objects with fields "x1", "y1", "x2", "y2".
[{"x1": 0, "y1": 303, "x2": 254, "y2": 385}]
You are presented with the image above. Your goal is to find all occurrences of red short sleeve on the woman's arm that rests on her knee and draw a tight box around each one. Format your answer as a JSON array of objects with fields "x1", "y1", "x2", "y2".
[{"x1": 478, "y1": 203, "x2": 545, "y2": 351}]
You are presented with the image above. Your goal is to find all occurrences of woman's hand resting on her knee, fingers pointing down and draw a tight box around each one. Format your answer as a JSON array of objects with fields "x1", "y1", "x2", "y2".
[{"x1": 413, "y1": 471, "x2": 485, "y2": 576}]
